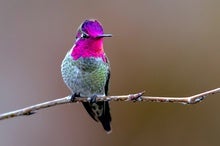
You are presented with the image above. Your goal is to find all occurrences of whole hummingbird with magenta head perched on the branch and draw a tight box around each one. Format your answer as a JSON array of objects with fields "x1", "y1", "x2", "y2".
[{"x1": 61, "y1": 19, "x2": 112, "y2": 133}]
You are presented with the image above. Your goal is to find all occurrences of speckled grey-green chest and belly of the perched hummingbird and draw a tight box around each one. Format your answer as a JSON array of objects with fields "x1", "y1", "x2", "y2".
[{"x1": 61, "y1": 51, "x2": 109, "y2": 96}]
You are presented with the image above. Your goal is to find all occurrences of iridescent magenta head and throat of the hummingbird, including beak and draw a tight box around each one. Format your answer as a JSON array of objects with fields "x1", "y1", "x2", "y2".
[{"x1": 71, "y1": 19, "x2": 112, "y2": 59}]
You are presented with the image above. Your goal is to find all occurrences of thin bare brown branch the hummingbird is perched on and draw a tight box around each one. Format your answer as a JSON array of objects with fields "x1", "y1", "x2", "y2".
[{"x1": 0, "y1": 88, "x2": 220, "y2": 120}]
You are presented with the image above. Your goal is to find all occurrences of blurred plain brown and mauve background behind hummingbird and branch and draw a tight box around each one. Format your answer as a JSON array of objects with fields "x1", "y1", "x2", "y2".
[{"x1": 0, "y1": 0, "x2": 220, "y2": 146}]
